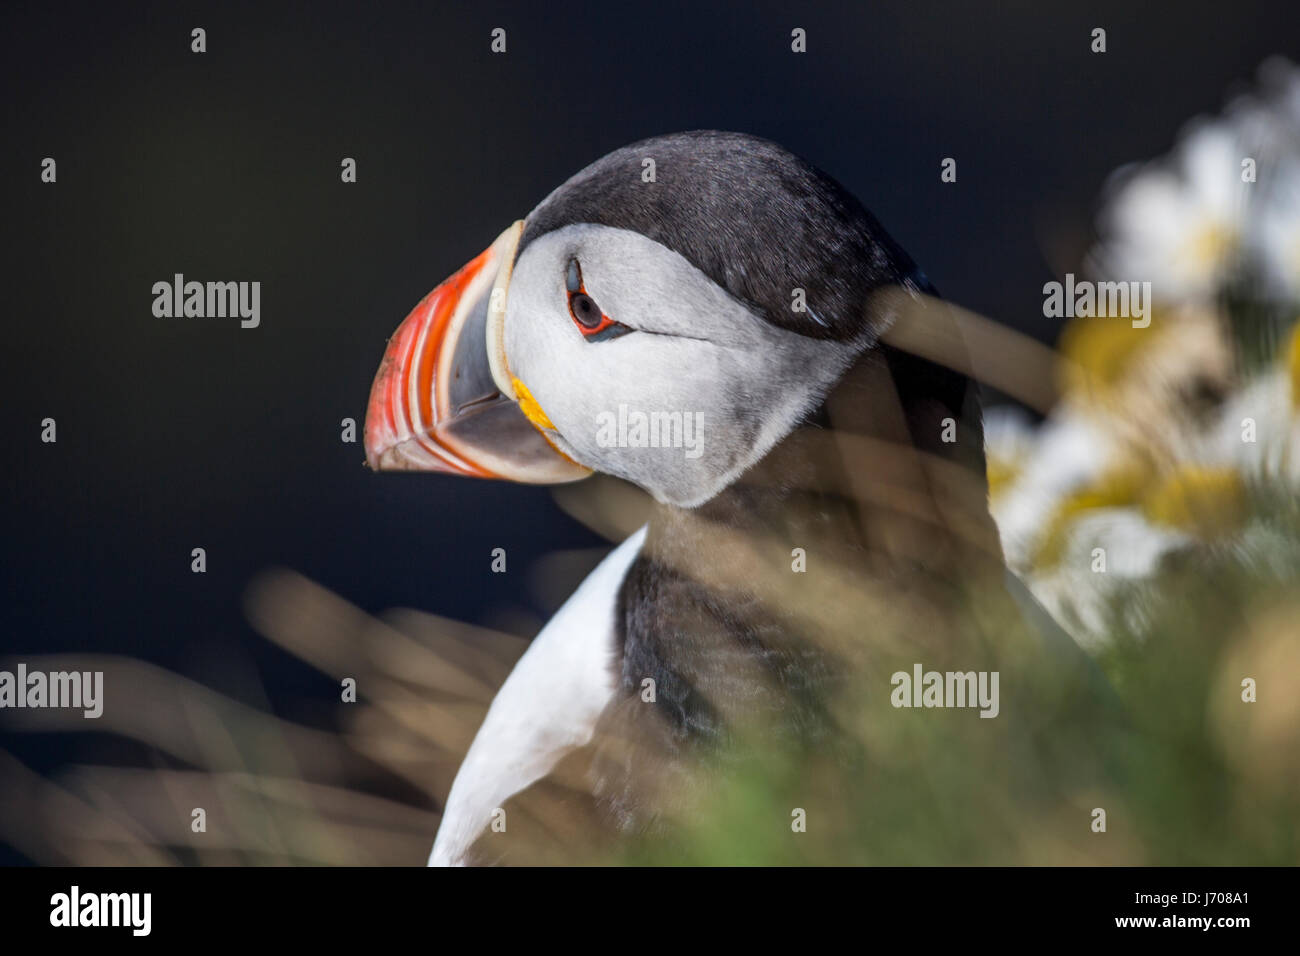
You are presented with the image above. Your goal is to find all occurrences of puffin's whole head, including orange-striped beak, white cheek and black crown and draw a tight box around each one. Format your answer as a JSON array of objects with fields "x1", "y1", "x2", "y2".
[{"x1": 365, "y1": 131, "x2": 946, "y2": 507}]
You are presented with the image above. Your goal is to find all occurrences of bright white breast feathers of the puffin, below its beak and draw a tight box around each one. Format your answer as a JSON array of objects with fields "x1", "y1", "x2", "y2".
[{"x1": 429, "y1": 528, "x2": 646, "y2": 866}]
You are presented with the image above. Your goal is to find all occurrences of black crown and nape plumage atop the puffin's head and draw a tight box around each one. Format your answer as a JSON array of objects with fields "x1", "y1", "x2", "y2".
[{"x1": 519, "y1": 130, "x2": 924, "y2": 341}]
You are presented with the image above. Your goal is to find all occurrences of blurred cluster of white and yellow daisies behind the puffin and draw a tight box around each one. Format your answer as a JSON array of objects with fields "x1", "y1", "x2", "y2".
[{"x1": 988, "y1": 60, "x2": 1300, "y2": 645}]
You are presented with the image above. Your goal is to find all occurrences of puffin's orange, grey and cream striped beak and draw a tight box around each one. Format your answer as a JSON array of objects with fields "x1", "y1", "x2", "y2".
[{"x1": 365, "y1": 222, "x2": 590, "y2": 484}]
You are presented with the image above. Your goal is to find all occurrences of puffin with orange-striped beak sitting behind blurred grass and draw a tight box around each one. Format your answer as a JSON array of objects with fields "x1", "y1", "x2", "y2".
[{"x1": 364, "y1": 130, "x2": 1107, "y2": 865}]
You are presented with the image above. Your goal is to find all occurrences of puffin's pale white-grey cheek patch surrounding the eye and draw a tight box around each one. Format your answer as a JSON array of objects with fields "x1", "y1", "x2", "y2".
[{"x1": 503, "y1": 224, "x2": 857, "y2": 507}]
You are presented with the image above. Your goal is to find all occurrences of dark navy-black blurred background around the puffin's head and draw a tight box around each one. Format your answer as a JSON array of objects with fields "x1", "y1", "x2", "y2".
[{"x1": 0, "y1": 0, "x2": 1300, "y2": 862}]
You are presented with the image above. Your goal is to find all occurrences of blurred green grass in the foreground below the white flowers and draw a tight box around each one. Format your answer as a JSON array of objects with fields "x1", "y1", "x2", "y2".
[{"x1": 616, "y1": 499, "x2": 1300, "y2": 865}]
